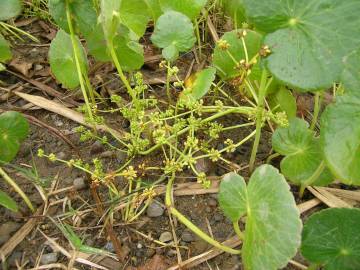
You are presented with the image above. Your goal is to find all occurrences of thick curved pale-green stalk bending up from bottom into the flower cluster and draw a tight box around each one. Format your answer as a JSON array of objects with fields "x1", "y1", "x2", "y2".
[{"x1": 165, "y1": 175, "x2": 241, "y2": 254}]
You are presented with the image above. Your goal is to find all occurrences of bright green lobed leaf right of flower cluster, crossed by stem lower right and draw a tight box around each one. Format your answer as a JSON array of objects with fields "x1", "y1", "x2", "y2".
[{"x1": 272, "y1": 118, "x2": 333, "y2": 186}]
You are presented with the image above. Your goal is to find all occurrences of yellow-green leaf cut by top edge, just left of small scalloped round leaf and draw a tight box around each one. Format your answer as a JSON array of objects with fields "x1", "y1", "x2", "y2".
[{"x1": 120, "y1": 0, "x2": 150, "y2": 37}]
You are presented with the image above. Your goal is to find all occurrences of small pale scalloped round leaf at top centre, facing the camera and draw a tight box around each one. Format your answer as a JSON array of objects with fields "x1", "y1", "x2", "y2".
[{"x1": 151, "y1": 11, "x2": 196, "y2": 61}]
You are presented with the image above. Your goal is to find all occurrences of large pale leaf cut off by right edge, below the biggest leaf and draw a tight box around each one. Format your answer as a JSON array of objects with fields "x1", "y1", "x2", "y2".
[{"x1": 321, "y1": 92, "x2": 360, "y2": 185}]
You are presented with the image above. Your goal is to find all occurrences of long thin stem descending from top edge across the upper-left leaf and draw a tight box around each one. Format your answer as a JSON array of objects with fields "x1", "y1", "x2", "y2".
[{"x1": 65, "y1": 0, "x2": 94, "y2": 122}]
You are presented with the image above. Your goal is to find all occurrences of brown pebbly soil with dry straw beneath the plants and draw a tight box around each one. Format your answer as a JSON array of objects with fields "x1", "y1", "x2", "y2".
[{"x1": 0, "y1": 15, "x2": 356, "y2": 270}]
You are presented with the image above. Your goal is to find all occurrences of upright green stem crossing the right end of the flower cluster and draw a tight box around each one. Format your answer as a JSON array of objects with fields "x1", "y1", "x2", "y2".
[{"x1": 249, "y1": 69, "x2": 267, "y2": 172}]
